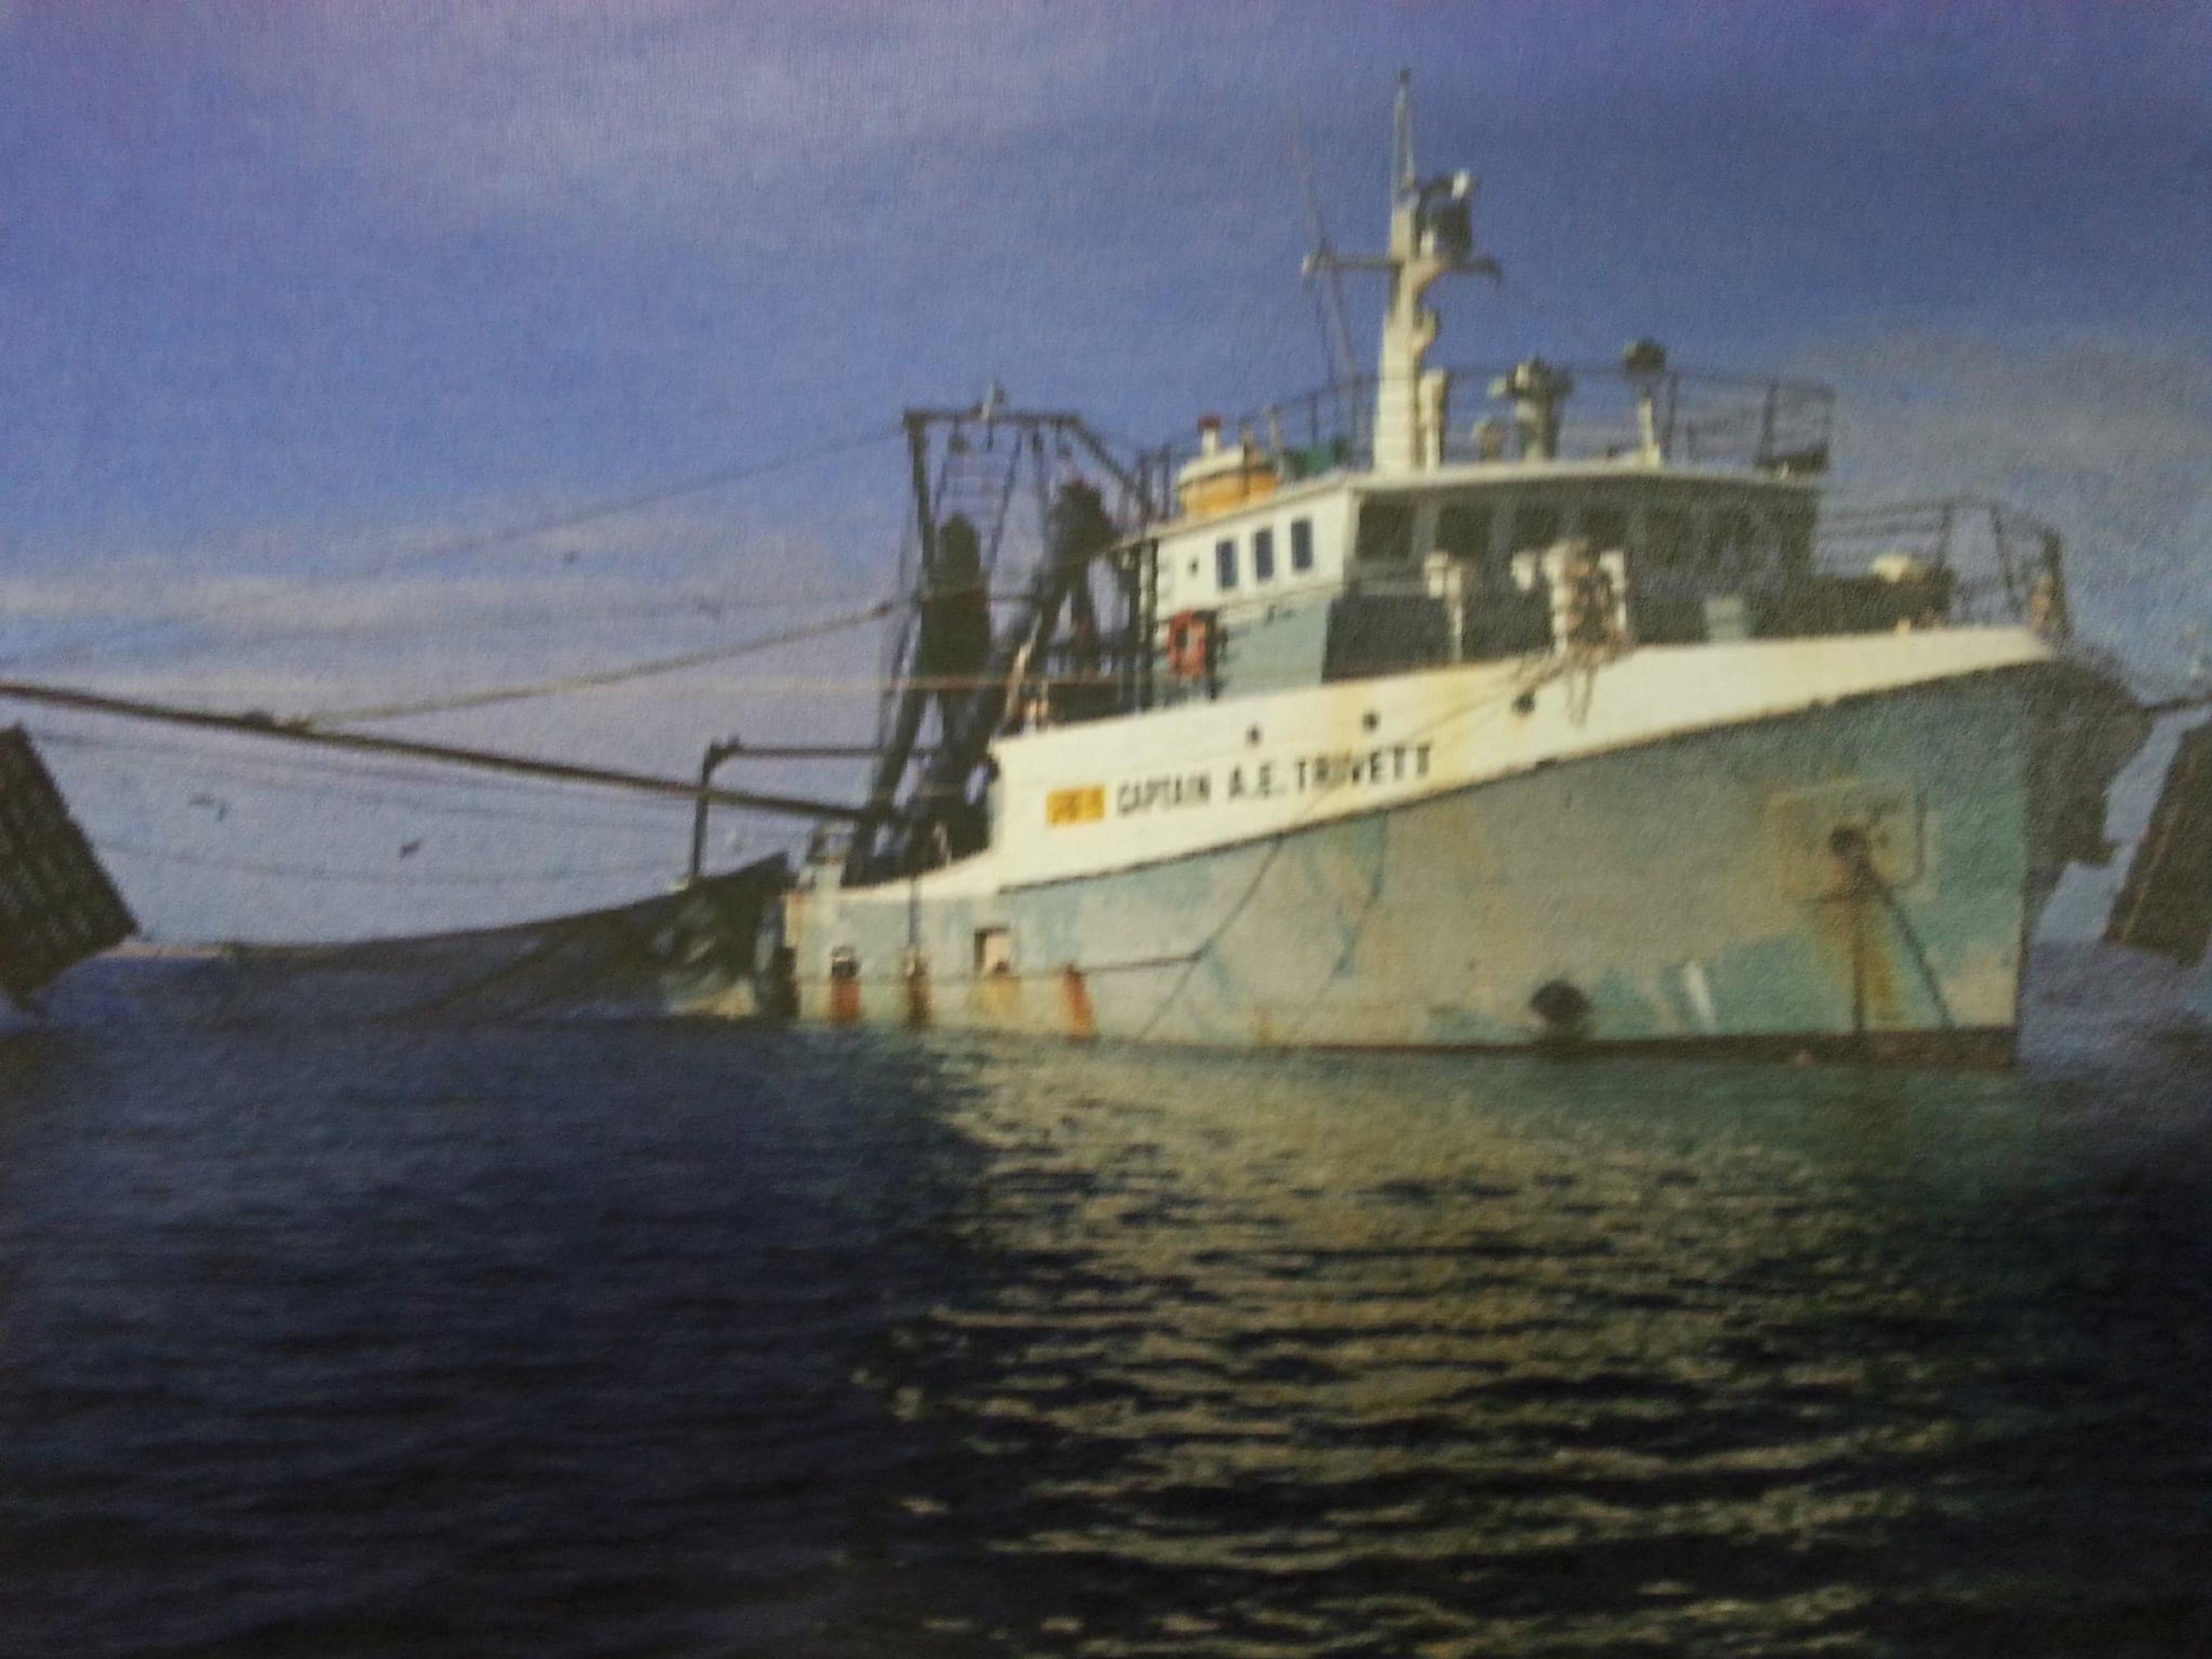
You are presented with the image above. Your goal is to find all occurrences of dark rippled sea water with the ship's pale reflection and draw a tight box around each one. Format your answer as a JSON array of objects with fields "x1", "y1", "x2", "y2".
[{"x1": 0, "y1": 964, "x2": 2212, "y2": 1659}]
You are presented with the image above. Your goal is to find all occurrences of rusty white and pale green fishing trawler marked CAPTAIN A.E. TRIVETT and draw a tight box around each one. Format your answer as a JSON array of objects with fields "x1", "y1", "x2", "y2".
[{"x1": 763, "y1": 86, "x2": 2148, "y2": 1064}]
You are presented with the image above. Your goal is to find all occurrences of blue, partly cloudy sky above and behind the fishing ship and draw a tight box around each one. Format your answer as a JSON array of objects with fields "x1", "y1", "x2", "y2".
[{"x1": 0, "y1": 0, "x2": 2212, "y2": 938}]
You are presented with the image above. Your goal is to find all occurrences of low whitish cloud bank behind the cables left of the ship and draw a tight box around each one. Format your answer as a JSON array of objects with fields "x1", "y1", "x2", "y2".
[{"x1": 0, "y1": 480, "x2": 896, "y2": 772}]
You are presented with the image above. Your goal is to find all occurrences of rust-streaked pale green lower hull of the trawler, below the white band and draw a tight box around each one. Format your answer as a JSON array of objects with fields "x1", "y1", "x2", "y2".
[{"x1": 783, "y1": 666, "x2": 2128, "y2": 1064}]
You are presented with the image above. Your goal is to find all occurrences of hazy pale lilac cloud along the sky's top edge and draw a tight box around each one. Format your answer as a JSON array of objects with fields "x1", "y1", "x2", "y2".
[{"x1": 252, "y1": 0, "x2": 1212, "y2": 241}]
